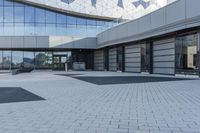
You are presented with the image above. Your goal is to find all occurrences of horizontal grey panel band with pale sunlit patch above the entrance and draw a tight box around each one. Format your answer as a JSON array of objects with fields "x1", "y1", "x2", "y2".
[{"x1": 0, "y1": 36, "x2": 97, "y2": 49}]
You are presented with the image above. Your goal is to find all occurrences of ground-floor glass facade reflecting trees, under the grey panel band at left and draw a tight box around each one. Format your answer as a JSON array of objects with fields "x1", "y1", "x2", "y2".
[{"x1": 0, "y1": 50, "x2": 71, "y2": 70}]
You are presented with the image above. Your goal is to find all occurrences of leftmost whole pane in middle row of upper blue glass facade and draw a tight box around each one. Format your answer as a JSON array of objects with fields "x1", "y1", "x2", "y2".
[{"x1": 4, "y1": 7, "x2": 13, "y2": 22}]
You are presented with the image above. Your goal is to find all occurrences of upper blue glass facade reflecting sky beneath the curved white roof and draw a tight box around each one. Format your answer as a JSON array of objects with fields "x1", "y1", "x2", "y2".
[{"x1": 0, "y1": 0, "x2": 116, "y2": 37}]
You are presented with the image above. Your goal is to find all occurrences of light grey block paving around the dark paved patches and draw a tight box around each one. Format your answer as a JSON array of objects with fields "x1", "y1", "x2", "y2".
[{"x1": 0, "y1": 72, "x2": 200, "y2": 133}]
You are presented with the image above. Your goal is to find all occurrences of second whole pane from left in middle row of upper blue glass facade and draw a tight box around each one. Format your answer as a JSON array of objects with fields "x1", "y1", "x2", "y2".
[{"x1": 14, "y1": 7, "x2": 24, "y2": 22}]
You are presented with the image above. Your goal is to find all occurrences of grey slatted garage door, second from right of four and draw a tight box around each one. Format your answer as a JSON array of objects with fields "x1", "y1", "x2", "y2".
[{"x1": 125, "y1": 45, "x2": 141, "y2": 72}]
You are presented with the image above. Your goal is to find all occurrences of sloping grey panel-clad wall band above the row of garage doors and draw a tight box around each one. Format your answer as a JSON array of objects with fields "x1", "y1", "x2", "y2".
[{"x1": 97, "y1": 0, "x2": 200, "y2": 48}]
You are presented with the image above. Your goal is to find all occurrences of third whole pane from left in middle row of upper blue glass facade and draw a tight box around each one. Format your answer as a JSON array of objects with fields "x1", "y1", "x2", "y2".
[{"x1": 25, "y1": 6, "x2": 35, "y2": 23}]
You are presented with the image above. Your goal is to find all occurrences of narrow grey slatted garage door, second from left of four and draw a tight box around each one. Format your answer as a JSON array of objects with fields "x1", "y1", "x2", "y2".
[{"x1": 109, "y1": 48, "x2": 117, "y2": 71}]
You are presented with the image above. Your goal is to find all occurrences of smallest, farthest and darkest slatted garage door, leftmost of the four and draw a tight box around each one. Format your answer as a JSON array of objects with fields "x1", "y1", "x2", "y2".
[{"x1": 94, "y1": 50, "x2": 104, "y2": 71}]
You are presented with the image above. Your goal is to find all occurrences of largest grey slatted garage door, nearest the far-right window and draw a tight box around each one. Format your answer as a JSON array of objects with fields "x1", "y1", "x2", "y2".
[{"x1": 153, "y1": 39, "x2": 175, "y2": 74}]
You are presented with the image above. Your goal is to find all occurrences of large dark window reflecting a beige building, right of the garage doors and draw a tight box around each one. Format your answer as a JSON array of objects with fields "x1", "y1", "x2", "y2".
[{"x1": 176, "y1": 34, "x2": 198, "y2": 74}]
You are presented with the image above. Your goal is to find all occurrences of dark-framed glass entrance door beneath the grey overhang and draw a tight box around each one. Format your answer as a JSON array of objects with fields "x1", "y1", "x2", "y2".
[{"x1": 53, "y1": 55, "x2": 67, "y2": 70}]
